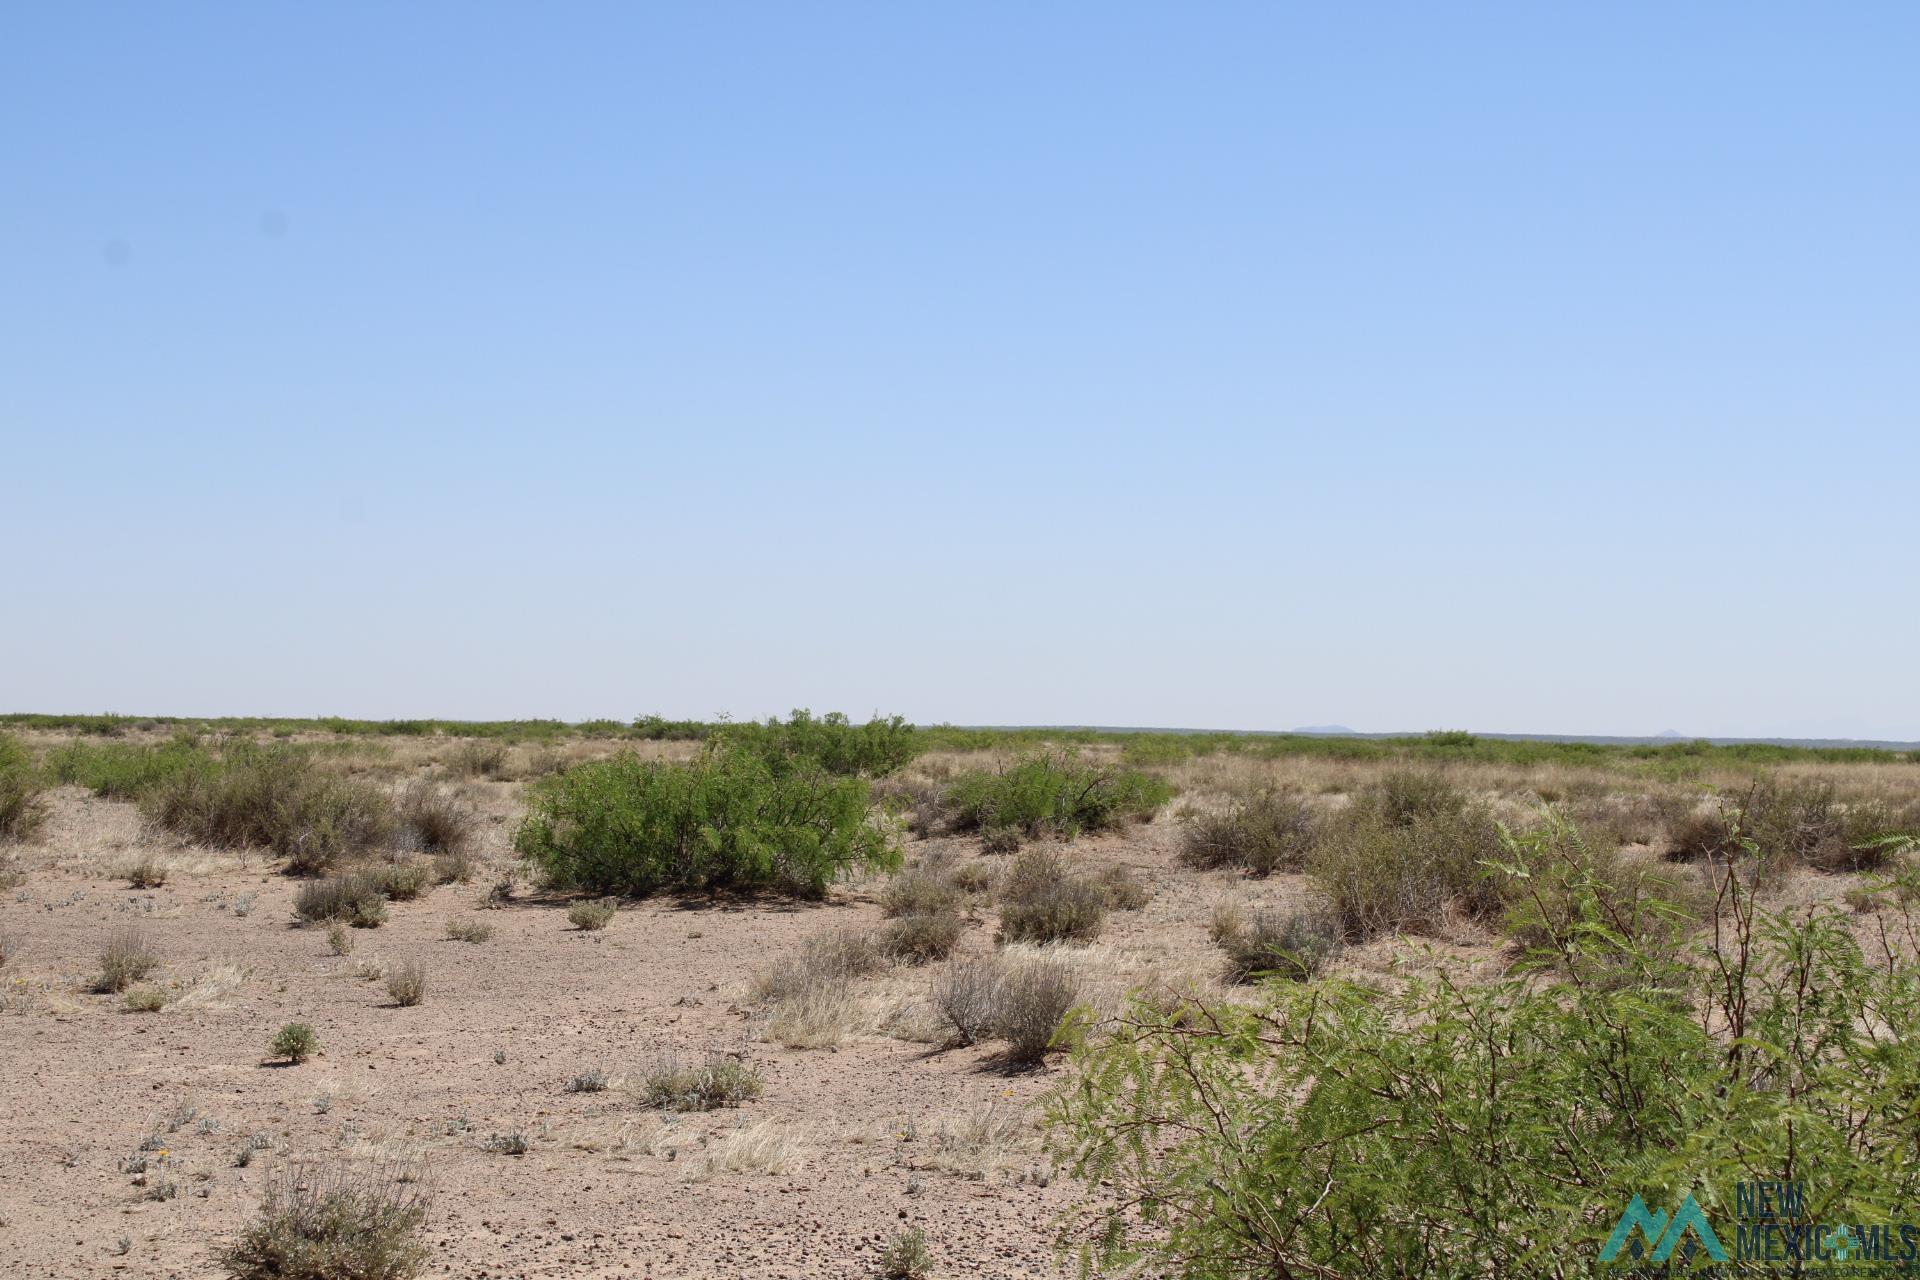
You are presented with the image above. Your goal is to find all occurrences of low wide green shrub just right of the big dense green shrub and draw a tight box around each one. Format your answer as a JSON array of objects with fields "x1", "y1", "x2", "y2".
[{"x1": 947, "y1": 752, "x2": 1173, "y2": 839}]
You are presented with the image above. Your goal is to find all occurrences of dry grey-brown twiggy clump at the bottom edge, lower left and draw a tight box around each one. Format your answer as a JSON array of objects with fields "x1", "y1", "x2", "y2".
[{"x1": 219, "y1": 1165, "x2": 432, "y2": 1280}]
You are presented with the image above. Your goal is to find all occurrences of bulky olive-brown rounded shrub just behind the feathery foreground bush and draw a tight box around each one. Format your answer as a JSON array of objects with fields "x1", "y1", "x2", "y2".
[{"x1": 1308, "y1": 794, "x2": 1501, "y2": 938}]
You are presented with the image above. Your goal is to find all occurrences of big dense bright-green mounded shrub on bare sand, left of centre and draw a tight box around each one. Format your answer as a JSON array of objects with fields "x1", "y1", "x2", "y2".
[{"x1": 515, "y1": 747, "x2": 899, "y2": 896}]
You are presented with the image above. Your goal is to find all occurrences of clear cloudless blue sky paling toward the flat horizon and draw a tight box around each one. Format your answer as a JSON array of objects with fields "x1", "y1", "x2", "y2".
[{"x1": 0, "y1": 2, "x2": 1920, "y2": 739}]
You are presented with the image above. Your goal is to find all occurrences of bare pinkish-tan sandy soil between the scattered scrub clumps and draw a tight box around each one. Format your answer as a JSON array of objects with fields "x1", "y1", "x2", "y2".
[{"x1": 0, "y1": 785, "x2": 1328, "y2": 1278}]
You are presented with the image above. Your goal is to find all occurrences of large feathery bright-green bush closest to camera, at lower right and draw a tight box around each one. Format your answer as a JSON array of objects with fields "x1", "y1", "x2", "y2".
[{"x1": 1048, "y1": 833, "x2": 1920, "y2": 1280}]
